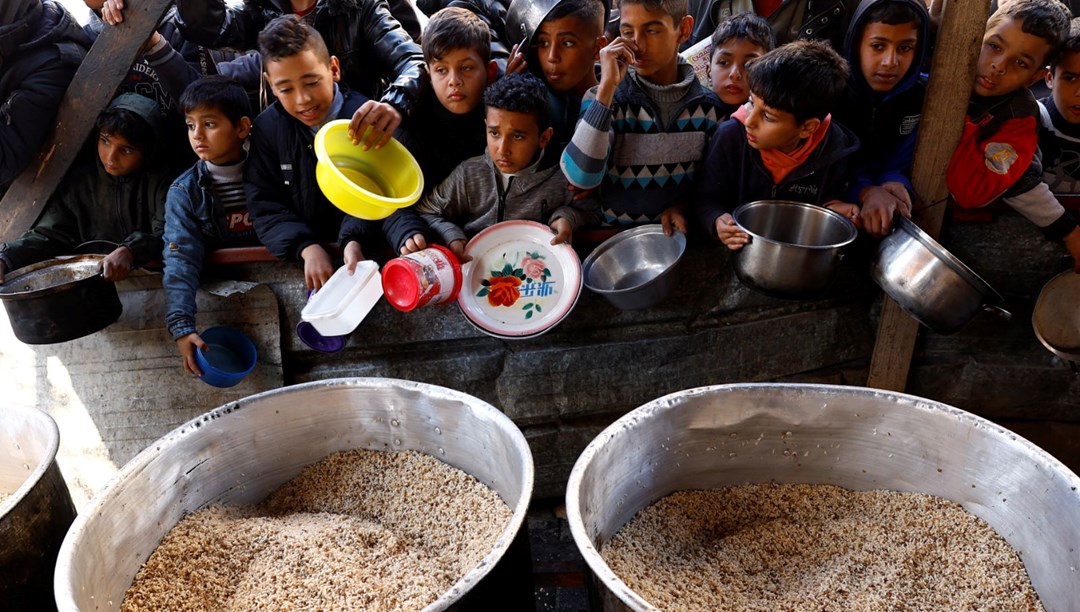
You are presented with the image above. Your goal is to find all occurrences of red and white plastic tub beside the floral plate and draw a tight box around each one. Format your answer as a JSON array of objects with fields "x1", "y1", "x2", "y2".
[{"x1": 382, "y1": 245, "x2": 461, "y2": 312}]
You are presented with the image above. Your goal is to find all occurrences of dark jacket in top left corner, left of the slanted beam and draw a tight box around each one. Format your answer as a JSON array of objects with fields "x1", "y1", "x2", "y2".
[{"x1": 0, "y1": 0, "x2": 91, "y2": 195}]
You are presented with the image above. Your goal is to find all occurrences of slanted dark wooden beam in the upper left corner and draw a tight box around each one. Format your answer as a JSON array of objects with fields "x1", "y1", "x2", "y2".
[{"x1": 0, "y1": 0, "x2": 172, "y2": 241}]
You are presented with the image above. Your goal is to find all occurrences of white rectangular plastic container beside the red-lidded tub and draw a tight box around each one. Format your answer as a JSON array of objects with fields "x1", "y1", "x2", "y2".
[{"x1": 300, "y1": 261, "x2": 382, "y2": 336}]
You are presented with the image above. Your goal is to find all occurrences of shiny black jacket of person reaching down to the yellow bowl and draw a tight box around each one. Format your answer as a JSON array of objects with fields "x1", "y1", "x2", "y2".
[{"x1": 176, "y1": 0, "x2": 427, "y2": 115}]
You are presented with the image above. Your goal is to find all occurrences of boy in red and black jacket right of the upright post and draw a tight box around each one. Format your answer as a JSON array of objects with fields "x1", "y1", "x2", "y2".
[{"x1": 945, "y1": 0, "x2": 1080, "y2": 270}]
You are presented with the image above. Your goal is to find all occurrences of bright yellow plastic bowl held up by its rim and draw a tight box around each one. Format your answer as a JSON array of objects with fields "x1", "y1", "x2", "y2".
[{"x1": 315, "y1": 119, "x2": 423, "y2": 220}]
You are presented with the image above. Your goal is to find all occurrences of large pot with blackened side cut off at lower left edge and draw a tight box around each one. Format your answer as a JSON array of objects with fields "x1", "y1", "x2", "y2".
[{"x1": 0, "y1": 406, "x2": 75, "y2": 610}]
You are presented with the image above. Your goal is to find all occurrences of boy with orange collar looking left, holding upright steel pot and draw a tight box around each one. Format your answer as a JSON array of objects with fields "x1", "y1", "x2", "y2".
[{"x1": 694, "y1": 41, "x2": 859, "y2": 250}]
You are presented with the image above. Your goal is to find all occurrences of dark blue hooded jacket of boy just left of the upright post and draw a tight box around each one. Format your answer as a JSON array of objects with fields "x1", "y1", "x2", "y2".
[{"x1": 833, "y1": 0, "x2": 930, "y2": 202}]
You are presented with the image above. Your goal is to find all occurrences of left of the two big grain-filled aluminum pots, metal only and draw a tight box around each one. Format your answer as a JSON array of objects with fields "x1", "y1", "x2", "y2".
[{"x1": 55, "y1": 378, "x2": 534, "y2": 612}]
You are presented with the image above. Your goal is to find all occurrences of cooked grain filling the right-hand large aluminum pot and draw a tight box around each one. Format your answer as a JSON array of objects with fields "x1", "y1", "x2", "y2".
[{"x1": 600, "y1": 485, "x2": 1043, "y2": 612}]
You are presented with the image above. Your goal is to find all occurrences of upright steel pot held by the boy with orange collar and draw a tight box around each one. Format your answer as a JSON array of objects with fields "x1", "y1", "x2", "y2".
[{"x1": 732, "y1": 200, "x2": 859, "y2": 298}]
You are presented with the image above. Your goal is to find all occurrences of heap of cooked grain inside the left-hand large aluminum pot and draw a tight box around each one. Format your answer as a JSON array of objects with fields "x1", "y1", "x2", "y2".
[{"x1": 121, "y1": 450, "x2": 512, "y2": 611}]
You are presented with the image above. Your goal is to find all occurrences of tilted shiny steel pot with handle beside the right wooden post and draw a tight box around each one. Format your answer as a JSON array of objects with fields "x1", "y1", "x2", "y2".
[{"x1": 870, "y1": 215, "x2": 1012, "y2": 334}]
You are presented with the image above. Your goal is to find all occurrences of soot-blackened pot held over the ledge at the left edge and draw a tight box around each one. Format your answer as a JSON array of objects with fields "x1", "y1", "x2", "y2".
[{"x1": 0, "y1": 255, "x2": 123, "y2": 344}]
